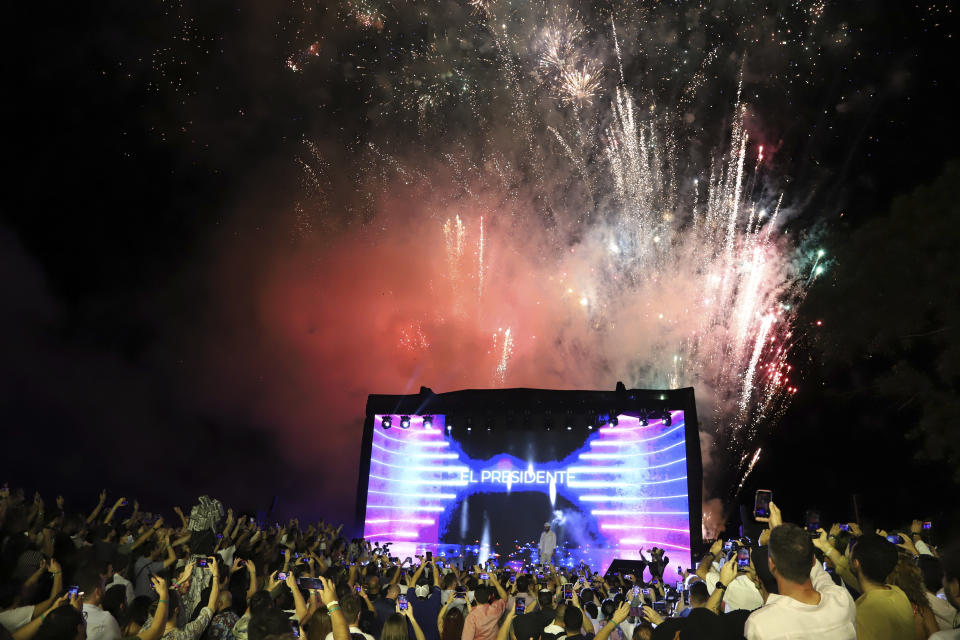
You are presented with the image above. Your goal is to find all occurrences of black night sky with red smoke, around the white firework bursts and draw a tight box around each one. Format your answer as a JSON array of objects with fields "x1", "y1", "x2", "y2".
[{"x1": 0, "y1": 0, "x2": 960, "y2": 536}]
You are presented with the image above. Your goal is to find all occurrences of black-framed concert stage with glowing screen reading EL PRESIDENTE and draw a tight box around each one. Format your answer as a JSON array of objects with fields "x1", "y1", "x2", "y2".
[{"x1": 356, "y1": 385, "x2": 701, "y2": 580}]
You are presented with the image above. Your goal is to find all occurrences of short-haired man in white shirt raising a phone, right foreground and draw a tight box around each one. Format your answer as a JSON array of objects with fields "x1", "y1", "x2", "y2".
[{"x1": 744, "y1": 524, "x2": 857, "y2": 640}]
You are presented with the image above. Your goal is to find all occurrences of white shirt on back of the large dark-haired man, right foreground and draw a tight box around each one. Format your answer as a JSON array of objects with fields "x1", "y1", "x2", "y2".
[{"x1": 744, "y1": 565, "x2": 856, "y2": 640}]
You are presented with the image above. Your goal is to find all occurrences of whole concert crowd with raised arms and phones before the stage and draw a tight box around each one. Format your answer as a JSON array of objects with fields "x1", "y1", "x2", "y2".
[{"x1": 0, "y1": 487, "x2": 960, "y2": 640}]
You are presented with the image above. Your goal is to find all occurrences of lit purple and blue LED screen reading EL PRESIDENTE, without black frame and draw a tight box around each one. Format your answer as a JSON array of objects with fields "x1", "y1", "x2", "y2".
[{"x1": 364, "y1": 411, "x2": 690, "y2": 579}]
